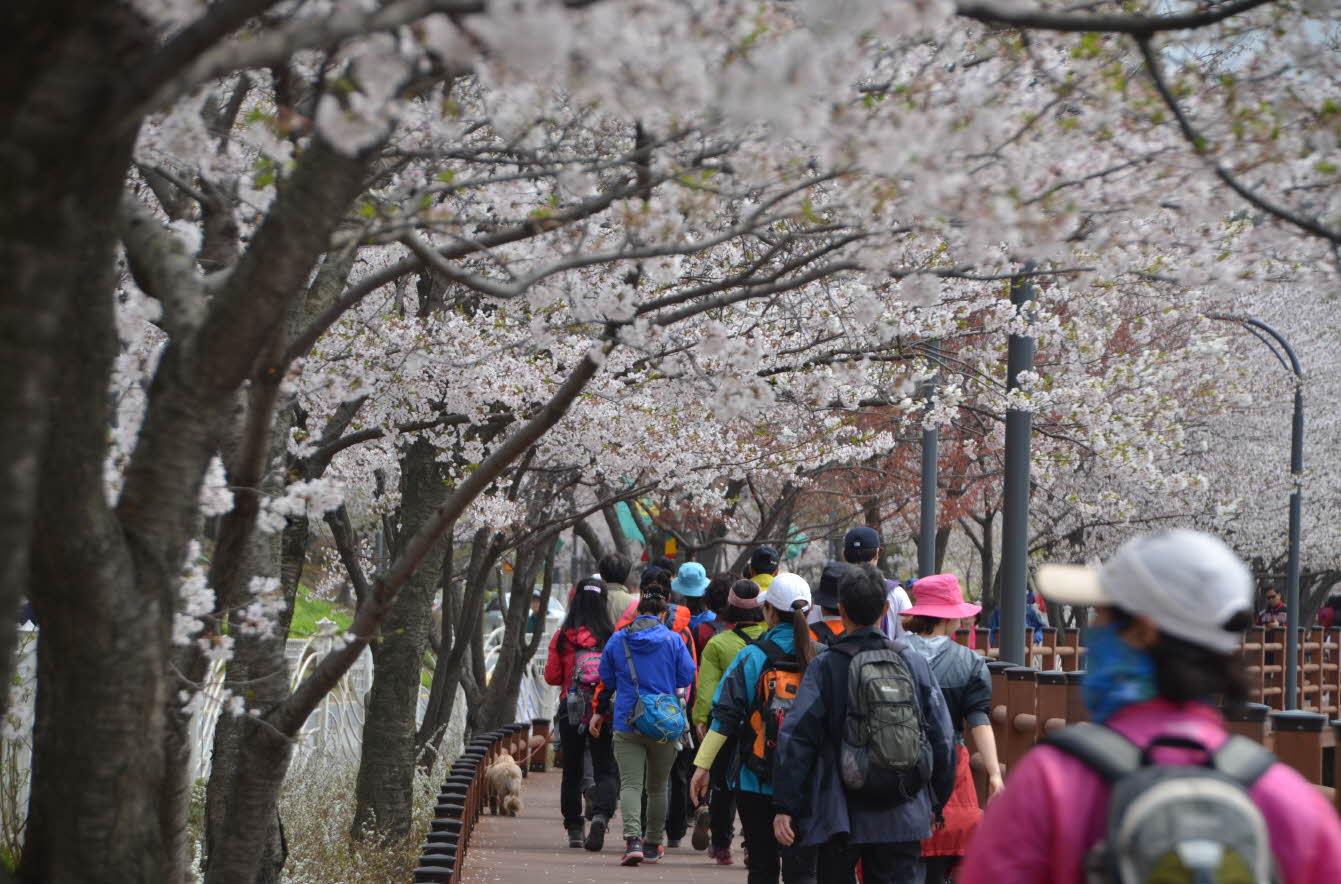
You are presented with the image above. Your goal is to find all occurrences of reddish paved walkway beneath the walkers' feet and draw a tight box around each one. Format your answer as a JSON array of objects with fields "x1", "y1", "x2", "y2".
[{"x1": 461, "y1": 770, "x2": 746, "y2": 884}]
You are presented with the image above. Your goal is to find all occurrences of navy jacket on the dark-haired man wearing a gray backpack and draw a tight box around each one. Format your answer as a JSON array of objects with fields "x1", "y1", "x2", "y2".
[{"x1": 772, "y1": 626, "x2": 955, "y2": 846}]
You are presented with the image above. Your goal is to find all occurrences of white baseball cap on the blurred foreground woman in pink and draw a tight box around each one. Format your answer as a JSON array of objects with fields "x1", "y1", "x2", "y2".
[{"x1": 1038, "y1": 529, "x2": 1252, "y2": 653}]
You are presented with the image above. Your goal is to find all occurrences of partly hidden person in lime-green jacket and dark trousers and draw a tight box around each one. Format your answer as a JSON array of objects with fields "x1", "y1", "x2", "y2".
[{"x1": 692, "y1": 579, "x2": 767, "y2": 865}]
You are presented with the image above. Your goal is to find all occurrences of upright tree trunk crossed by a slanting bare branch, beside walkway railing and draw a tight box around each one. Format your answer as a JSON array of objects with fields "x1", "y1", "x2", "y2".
[{"x1": 353, "y1": 439, "x2": 447, "y2": 841}]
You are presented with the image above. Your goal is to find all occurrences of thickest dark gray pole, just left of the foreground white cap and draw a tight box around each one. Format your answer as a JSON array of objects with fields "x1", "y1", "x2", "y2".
[{"x1": 1000, "y1": 262, "x2": 1035, "y2": 665}]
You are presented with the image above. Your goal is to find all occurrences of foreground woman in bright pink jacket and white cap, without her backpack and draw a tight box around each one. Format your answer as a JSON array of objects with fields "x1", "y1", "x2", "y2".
[{"x1": 956, "y1": 530, "x2": 1341, "y2": 884}]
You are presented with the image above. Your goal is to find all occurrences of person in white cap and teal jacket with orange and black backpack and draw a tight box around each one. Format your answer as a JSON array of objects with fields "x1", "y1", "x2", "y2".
[{"x1": 691, "y1": 574, "x2": 815, "y2": 884}]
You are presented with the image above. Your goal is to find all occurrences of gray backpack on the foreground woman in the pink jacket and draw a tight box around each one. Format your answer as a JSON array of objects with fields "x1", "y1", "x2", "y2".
[{"x1": 1045, "y1": 724, "x2": 1279, "y2": 884}]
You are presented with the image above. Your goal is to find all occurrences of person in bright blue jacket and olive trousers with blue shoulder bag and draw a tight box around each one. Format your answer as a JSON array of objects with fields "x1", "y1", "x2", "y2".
[{"x1": 590, "y1": 590, "x2": 695, "y2": 865}]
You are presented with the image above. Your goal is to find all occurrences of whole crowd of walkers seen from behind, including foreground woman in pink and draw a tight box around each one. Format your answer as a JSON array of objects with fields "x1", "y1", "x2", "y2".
[{"x1": 546, "y1": 527, "x2": 1341, "y2": 884}]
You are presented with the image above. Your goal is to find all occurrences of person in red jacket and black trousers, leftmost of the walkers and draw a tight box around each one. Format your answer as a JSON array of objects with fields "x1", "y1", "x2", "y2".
[{"x1": 544, "y1": 575, "x2": 620, "y2": 850}]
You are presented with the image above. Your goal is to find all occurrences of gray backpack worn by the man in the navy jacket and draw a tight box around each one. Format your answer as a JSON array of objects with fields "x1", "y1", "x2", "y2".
[{"x1": 830, "y1": 641, "x2": 932, "y2": 806}]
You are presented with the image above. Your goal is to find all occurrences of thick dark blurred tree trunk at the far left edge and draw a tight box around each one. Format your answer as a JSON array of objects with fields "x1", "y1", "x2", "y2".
[{"x1": 16, "y1": 10, "x2": 163, "y2": 884}]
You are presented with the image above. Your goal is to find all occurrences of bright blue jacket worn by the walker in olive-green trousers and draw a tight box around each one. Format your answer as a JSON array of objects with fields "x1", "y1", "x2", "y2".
[{"x1": 601, "y1": 614, "x2": 695, "y2": 731}]
